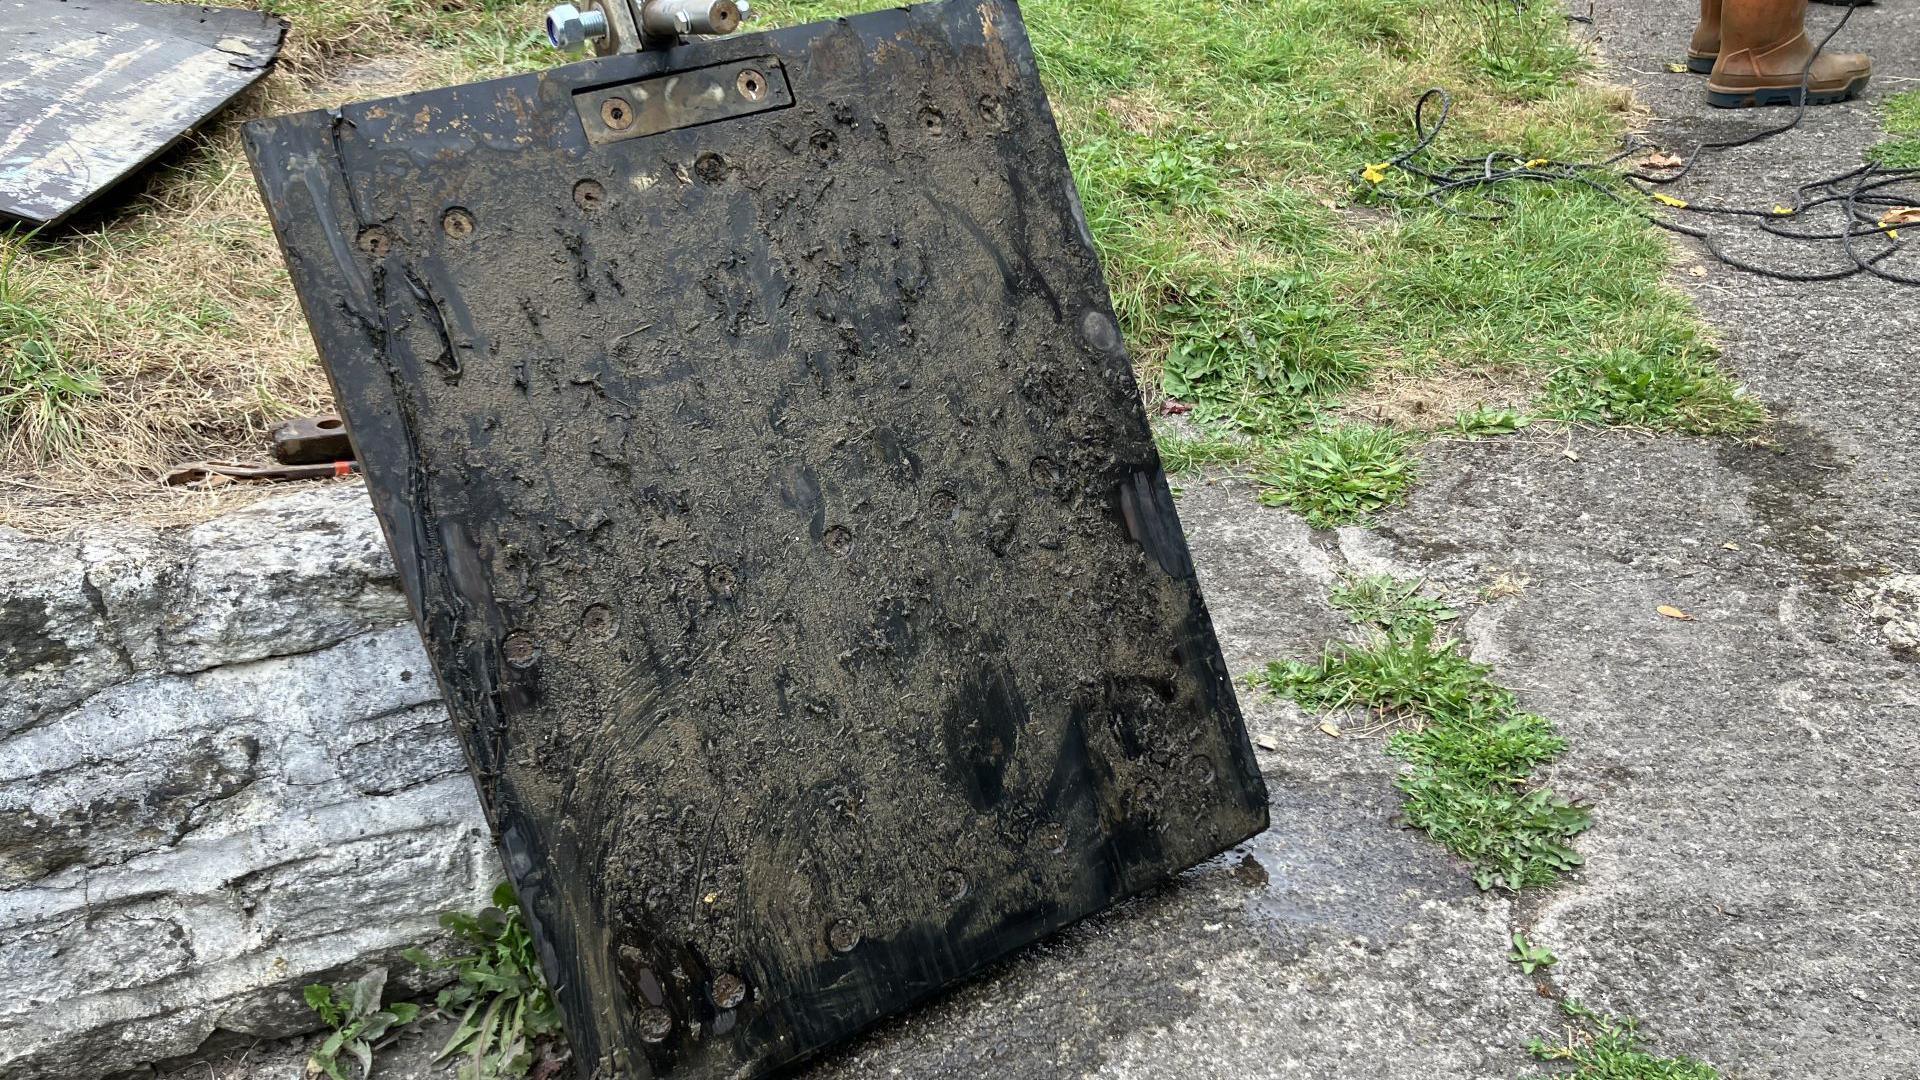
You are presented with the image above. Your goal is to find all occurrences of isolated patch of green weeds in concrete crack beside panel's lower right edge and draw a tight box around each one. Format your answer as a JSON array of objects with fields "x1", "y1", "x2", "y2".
[{"x1": 1261, "y1": 578, "x2": 1592, "y2": 892}]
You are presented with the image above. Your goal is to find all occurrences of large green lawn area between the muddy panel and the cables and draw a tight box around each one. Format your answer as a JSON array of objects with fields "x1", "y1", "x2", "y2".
[{"x1": 802, "y1": 0, "x2": 1761, "y2": 525}]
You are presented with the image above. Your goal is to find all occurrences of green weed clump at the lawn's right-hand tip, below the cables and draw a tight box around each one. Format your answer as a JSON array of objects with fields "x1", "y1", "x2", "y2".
[{"x1": 1546, "y1": 350, "x2": 1766, "y2": 434}]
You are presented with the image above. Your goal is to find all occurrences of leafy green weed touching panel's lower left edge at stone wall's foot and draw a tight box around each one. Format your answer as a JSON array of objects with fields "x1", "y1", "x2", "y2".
[{"x1": 405, "y1": 882, "x2": 561, "y2": 1080}]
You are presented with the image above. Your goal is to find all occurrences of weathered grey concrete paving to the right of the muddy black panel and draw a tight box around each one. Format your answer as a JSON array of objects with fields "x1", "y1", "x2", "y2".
[{"x1": 123, "y1": 0, "x2": 1920, "y2": 1080}]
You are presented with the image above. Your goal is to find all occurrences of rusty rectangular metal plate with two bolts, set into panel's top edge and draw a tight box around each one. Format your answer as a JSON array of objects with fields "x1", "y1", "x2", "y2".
[{"x1": 574, "y1": 56, "x2": 793, "y2": 146}]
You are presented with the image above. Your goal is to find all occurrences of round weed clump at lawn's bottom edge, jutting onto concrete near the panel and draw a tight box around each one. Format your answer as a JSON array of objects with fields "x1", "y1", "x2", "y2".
[{"x1": 1260, "y1": 425, "x2": 1415, "y2": 528}]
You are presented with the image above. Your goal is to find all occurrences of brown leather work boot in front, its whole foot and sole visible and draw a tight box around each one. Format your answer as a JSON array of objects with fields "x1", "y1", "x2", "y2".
[{"x1": 1707, "y1": 0, "x2": 1874, "y2": 110}]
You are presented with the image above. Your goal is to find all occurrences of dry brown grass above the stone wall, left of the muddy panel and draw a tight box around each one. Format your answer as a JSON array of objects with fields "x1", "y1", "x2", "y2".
[{"x1": 0, "y1": 0, "x2": 534, "y2": 532}]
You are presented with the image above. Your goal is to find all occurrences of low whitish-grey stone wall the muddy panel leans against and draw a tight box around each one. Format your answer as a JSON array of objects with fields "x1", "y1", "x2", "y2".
[{"x1": 0, "y1": 484, "x2": 499, "y2": 1080}]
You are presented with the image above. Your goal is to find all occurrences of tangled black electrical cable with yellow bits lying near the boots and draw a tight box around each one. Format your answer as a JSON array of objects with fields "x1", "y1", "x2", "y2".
[{"x1": 1356, "y1": 4, "x2": 1920, "y2": 284}]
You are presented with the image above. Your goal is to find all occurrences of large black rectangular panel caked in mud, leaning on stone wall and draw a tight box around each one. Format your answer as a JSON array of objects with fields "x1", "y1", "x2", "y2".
[{"x1": 248, "y1": 0, "x2": 1267, "y2": 1076}]
